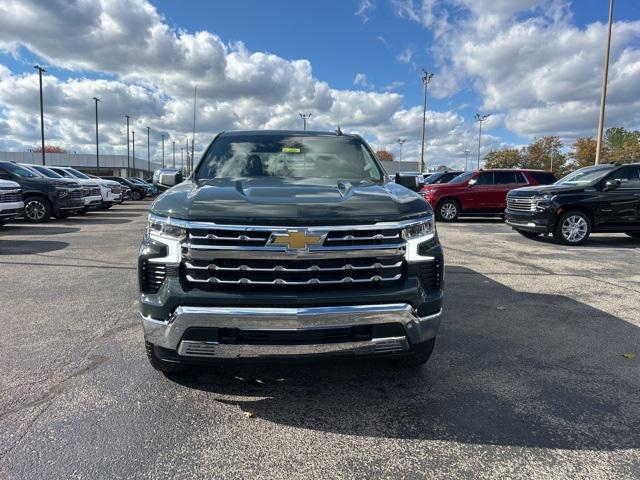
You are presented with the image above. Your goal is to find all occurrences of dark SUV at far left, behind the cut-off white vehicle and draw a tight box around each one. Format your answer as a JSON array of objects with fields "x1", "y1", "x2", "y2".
[{"x1": 0, "y1": 161, "x2": 84, "y2": 223}]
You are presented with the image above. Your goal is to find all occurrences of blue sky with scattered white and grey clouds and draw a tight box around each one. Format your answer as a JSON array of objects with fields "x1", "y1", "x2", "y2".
[{"x1": 0, "y1": 0, "x2": 640, "y2": 167}]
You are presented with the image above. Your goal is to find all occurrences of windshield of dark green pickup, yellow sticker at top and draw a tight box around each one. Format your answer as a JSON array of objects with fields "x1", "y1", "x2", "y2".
[{"x1": 196, "y1": 134, "x2": 384, "y2": 183}]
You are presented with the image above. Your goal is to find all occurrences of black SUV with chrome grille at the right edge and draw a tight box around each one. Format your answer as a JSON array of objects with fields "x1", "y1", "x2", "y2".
[{"x1": 505, "y1": 163, "x2": 640, "y2": 245}]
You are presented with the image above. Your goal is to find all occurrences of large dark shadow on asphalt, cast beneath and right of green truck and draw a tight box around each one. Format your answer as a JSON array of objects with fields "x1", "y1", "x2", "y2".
[{"x1": 171, "y1": 267, "x2": 640, "y2": 450}]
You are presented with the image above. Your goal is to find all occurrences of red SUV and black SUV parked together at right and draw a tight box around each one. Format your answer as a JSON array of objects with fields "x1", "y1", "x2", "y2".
[{"x1": 421, "y1": 163, "x2": 640, "y2": 245}]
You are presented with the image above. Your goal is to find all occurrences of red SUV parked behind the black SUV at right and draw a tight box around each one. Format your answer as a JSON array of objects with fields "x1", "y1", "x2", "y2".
[{"x1": 421, "y1": 169, "x2": 556, "y2": 222}]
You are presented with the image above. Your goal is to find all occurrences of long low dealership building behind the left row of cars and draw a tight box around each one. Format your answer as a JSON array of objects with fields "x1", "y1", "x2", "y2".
[{"x1": 0, "y1": 152, "x2": 175, "y2": 178}]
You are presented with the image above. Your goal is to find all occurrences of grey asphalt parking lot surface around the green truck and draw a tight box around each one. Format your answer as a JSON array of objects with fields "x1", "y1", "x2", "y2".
[{"x1": 0, "y1": 202, "x2": 640, "y2": 479}]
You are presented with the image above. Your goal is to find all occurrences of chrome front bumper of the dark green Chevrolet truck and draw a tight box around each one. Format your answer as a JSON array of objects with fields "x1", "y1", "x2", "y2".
[{"x1": 141, "y1": 303, "x2": 442, "y2": 359}]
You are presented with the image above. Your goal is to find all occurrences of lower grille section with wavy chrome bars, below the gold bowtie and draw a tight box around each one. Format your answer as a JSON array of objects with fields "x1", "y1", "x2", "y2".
[{"x1": 183, "y1": 256, "x2": 404, "y2": 287}]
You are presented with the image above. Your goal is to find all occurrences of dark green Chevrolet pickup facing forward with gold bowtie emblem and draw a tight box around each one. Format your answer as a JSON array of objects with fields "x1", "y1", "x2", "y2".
[{"x1": 138, "y1": 131, "x2": 444, "y2": 371}]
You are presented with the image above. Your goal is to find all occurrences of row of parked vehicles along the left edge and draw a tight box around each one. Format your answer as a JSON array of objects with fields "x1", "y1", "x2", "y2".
[{"x1": 0, "y1": 161, "x2": 157, "y2": 225}]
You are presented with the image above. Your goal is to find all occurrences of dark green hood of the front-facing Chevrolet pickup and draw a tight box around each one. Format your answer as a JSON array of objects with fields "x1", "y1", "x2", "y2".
[{"x1": 151, "y1": 177, "x2": 431, "y2": 225}]
